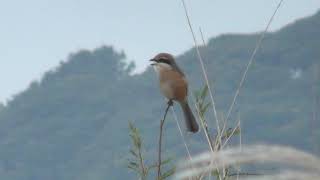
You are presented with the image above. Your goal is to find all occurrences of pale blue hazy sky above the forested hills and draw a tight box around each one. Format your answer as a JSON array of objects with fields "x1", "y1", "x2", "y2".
[{"x1": 0, "y1": 0, "x2": 320, "y2": 102}]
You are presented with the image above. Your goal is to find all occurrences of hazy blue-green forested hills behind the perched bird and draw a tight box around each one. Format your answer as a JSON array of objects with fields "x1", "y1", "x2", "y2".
[{"x1": 0, "y1": 12, "x2": 320, "y2": 180}]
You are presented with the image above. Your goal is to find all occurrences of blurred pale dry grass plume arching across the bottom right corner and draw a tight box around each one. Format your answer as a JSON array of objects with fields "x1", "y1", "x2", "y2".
[{"x1": 175, "y1": 145, "x2": 320, "y2": 180}]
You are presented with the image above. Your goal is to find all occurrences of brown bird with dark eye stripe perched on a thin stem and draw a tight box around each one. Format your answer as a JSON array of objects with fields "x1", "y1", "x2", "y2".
[{"x1": 150, "y1": 53, "x2": 199, "y2": 133}]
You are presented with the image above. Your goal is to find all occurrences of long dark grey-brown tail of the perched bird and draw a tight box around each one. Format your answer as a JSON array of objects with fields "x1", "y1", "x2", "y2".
[{"x1": 180, "y1": 101, "x2": 199, "y2": 133}]
